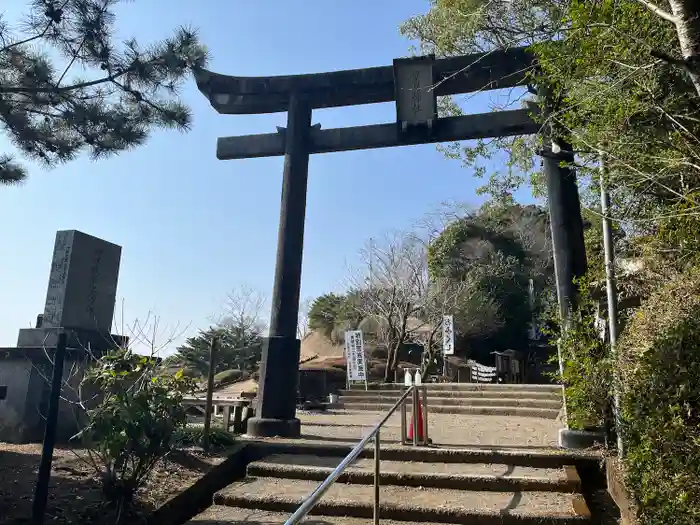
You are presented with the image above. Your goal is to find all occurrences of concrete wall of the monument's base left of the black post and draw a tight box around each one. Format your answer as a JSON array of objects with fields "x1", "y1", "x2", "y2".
[{"x1": 0, "y1": 359, "x2": 32, "y2": 443}]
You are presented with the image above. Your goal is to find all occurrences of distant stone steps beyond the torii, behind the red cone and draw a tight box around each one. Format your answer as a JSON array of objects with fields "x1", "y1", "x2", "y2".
[{"x1": 337, "y1": 383, "x2": 562, "y2": 419}]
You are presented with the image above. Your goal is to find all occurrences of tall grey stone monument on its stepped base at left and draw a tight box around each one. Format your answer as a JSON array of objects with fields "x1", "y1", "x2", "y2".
[{"x1": 0, "y1": 230, "x2": 126, "y2": 442}]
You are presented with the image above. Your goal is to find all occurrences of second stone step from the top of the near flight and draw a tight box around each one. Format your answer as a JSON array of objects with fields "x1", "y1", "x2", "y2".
[{"x1": 248, "y1": 454, "x2": 581, "y2": 492}]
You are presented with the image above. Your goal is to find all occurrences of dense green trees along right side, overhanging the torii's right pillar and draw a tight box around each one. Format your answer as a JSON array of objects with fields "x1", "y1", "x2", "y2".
[{"x1": 402, "y1": 0, "x2": 700, "y2": 525}]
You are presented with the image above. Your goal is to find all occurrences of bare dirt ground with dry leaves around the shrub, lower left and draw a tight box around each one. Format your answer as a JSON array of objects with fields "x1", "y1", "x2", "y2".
[{"x1": 0, "y1": 443, "x2": 224, "y2": 525}]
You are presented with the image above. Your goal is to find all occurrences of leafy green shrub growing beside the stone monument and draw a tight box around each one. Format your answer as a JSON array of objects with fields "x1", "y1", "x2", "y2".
[{"x1": 78, "y1": 349, "x2": 194, "y2": 508}]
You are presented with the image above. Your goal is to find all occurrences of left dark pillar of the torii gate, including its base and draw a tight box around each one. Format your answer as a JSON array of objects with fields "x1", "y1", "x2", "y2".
[{"x1": 248, "y1": 93, "x2": 311, "y2": 437}]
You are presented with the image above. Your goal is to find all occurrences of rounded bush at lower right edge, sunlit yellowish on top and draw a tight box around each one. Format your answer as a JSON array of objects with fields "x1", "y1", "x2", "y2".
[{"x1": 619, "y1": 270, "x2": 700, "y2": 525}]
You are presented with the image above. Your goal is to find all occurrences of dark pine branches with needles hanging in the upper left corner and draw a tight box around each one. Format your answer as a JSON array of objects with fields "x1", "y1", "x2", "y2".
[{"x1": 0, "y1": 0, "x2": 206, "y2": 184}]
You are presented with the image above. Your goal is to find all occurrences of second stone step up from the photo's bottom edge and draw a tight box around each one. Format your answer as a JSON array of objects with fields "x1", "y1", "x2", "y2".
[{"x1": 214, "y1": 477, "x2": 590, "y2": 525}]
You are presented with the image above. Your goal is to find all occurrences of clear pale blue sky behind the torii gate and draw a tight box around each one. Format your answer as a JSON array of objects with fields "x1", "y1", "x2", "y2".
[{"x1": 0, "y1": 0, "x2": 536, "y2": 352}]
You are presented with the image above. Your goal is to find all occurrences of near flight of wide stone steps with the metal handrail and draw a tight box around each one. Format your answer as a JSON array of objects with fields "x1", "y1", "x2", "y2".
[{"x1": 188, "y1": 442, "x2": 595, "y2": 525}]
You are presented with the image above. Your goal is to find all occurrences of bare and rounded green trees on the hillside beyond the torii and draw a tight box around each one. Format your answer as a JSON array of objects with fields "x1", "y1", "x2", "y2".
[{"x1": 309, "y1": 203, "x2": 553, "y2": 381}]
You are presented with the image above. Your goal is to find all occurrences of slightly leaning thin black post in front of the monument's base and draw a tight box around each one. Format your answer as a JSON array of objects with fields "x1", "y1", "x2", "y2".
[{"x1": 32, "y1": 333, "x2": 66, "y2": 525}]
